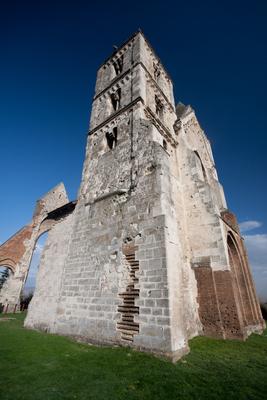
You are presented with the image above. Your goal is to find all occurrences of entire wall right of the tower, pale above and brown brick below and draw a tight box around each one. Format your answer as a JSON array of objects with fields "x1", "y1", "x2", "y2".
[{"x1": 178, "y1": 110, "x2": 263, "y2": 338}]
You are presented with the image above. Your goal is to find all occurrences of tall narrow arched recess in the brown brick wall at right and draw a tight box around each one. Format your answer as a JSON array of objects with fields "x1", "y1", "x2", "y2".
[{"x1": 227, "y1": 234, "x2": 253, "y2": 325}]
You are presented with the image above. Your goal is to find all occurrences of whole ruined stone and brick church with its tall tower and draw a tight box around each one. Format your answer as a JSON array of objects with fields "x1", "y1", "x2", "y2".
[{"x1": 0, "y1": 32, "x2": 264, "y2": 360}]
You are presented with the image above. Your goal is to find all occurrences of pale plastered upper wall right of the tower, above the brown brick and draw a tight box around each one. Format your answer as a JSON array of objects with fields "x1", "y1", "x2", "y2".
[{"x1": 178, "y1": 112, "x2": 227, "y2": 269}]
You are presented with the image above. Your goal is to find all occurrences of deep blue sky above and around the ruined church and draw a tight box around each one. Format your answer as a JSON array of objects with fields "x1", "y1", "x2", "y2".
[{"x1": 0, "y1": 0, "x2": 267, "y2": 296}]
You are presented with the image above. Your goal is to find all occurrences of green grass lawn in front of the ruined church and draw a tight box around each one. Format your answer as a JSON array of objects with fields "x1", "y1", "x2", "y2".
[{"x1": 0, "y1": 314, "x2": 267, "y2": 400}]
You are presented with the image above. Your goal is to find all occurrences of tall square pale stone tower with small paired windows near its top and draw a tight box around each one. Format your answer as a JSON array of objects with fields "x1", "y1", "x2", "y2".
[{"x1": 33, "y1": 32, "x2": 199, "y2": 353}]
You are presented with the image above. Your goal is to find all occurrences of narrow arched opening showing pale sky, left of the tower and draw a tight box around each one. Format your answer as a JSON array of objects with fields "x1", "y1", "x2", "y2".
[{"x1": 21, "y1": 232, "x2": 48, "y2": 309}]
